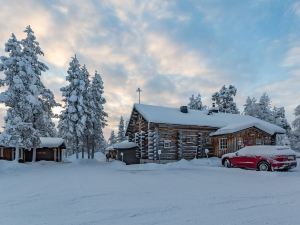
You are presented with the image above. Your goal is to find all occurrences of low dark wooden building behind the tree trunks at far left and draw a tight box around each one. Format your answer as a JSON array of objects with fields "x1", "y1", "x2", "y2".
[{"x1": 0, "y1": 137, "x2": 66, "y2": 162}]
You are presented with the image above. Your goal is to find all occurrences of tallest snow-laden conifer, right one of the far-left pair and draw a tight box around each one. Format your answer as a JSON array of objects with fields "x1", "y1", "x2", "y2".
[{"x1": 21, "y1": 26, "x2": 59, "y2": 137}]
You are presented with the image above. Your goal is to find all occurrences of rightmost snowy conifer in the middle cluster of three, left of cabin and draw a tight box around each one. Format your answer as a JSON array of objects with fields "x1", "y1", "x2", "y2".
[{"x1": 89, "y1": 71, "x2": 108, "y2": 158}]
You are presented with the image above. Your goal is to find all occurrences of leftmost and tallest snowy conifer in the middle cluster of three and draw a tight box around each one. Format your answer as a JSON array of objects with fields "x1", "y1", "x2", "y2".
[{"x1": 58, "y1": 55, "x2": 86, "y2": 159}]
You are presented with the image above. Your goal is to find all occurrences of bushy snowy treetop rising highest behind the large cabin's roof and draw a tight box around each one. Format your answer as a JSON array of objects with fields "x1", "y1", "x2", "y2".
[{"x1": 212, "y1": 85, "x2": 240, "y2": 114}]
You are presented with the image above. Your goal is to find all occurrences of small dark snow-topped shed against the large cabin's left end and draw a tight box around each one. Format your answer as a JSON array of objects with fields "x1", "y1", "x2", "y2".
[{"x1": 106, "y1": 140, "x2": 140, "y2": 165}]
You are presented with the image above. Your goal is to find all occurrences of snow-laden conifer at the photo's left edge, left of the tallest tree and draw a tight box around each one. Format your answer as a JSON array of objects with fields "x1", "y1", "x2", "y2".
[{"x1": 0, "y1": 34, "x2": 40, "y2": 161}]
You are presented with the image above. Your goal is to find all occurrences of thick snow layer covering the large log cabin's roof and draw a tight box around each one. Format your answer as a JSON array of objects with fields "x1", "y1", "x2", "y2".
[{"x1": 134, "y1": 104, "x2": 285, "y2": 135}]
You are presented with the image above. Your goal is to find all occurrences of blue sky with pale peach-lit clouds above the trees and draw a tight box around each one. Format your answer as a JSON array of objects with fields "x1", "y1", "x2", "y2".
[{"x1": 0, "y1": 0, "x2": 300, "y2": 136}]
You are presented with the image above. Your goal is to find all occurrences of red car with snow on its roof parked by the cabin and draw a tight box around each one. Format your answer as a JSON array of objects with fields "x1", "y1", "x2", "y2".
[{"x1": 222, "y1": 145, "x2": 297, "y2": 171}]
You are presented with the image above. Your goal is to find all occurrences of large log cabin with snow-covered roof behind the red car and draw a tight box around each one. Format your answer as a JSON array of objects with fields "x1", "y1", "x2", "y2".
[{"x1": 126, "y1": 104, "x2": 285, "y2": 163}]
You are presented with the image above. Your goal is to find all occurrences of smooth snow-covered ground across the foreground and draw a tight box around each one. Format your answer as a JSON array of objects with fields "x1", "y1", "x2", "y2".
[{"x1": 0, "y1": 156, "x2": 300, "y2": 225}]
